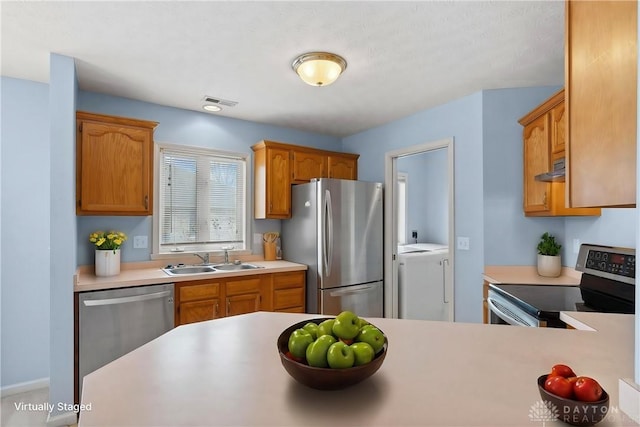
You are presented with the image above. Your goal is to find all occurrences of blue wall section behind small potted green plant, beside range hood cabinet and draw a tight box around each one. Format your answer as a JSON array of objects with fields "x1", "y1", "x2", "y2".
[{"x1": 482, "y1": 86, "x2": 564, "y2": 265}]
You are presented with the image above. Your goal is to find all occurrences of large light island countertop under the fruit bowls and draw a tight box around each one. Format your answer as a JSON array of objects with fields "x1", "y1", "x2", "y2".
[{"x1": 79, "y1": 312, "x2": 637, "y2": 427}]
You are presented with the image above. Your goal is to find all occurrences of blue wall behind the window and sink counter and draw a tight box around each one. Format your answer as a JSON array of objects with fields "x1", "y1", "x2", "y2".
[{"x1": 78, "y1": 92, "x2": 341, "y2": 265}]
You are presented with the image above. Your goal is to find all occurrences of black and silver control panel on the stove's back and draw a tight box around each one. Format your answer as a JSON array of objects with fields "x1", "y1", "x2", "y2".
[{"x1": 576, "y1": 245, "x2": 636, "y2": 285}]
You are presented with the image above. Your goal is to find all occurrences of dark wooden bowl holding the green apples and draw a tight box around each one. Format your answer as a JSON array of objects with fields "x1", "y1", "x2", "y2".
[{"x1": 278, "y1": 317, "x2": 389, "y2": 390}]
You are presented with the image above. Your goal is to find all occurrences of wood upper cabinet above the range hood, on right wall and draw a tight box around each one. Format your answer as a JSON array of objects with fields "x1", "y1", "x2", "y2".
[{"x1": 519, "y1": 90, "x2": 600, "y2": 216}]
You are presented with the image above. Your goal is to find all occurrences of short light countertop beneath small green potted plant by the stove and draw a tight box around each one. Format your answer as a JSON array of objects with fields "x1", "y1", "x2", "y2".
[{"x1": 483, "y1": 265, "x2": 582, "y2": 286}]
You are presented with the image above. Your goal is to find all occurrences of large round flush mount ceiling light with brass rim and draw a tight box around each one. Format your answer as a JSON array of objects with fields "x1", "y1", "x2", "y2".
[{"x1": 291, "y1": 52, "x2": 347, "y2": 86}]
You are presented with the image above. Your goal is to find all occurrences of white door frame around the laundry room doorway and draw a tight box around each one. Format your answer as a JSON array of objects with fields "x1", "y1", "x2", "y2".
[{"x1": 384, "y1": 137, "x2": 455, "y2": 321}]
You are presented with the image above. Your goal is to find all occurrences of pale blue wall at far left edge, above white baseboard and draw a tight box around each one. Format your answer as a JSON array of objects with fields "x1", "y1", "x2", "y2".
[{"x1": 0, "y1": 77, "x2": 50, "y2": 387}]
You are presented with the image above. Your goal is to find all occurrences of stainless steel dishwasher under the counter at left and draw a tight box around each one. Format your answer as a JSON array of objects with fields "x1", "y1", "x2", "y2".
[{"x1": 78, "y1": 283, "x2": 174, "y2": 398}]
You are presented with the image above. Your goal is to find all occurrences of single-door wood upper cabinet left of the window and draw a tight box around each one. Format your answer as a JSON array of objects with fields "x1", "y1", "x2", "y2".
[{"x1": 76, "y1": 111, "x2": 158, "y2": 215}]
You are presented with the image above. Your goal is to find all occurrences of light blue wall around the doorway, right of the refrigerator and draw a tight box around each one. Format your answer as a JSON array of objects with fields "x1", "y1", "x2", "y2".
[{"x1": 343, "y1": 93, "x2": 484, "y2": 322}]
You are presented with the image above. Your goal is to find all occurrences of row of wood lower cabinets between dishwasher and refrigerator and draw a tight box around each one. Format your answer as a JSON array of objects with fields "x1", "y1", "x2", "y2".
[{"x1": 175, "y1": 271, "x2": 306, "y2": 326}]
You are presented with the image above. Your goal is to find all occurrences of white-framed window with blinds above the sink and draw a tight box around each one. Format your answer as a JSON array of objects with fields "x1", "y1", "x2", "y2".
[{"x1": 154, "y1": 145, "x2": 247, "y2": 254}]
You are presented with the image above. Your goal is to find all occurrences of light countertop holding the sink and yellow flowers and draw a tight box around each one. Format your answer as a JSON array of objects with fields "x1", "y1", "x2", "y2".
[{"x1": 73, "y1": 261, "x2": 307, "y2": 292}]
